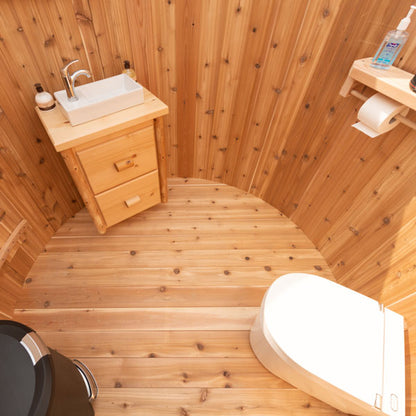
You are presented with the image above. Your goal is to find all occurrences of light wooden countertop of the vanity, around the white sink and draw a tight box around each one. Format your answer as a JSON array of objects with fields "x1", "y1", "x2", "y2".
[{"x1": 36, "y1": 88, "x2": 169, "y2": 152}]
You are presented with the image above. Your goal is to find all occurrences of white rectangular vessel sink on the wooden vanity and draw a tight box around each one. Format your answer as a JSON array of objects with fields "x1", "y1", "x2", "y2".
[{"x1": 54, "y1": 74, "x2": 144, "y2": 126}]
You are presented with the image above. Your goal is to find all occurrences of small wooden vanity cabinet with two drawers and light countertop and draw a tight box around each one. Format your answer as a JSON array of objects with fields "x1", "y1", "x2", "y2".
[{"x1": 36, "y1": 90, "x2": 168, "y2": 233}]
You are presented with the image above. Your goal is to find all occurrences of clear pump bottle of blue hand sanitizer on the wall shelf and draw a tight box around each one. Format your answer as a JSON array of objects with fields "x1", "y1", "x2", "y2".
[{"x1": 371, "y1": 6, "x2": 416, "y2": 69}]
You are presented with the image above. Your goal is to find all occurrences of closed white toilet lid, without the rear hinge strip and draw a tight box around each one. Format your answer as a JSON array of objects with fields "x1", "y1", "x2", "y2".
[{"x1": 262, "y1": 273, "x2": 384, "y2": 406}]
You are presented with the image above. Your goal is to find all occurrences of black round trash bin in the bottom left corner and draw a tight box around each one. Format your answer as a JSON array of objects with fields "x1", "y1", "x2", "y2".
[{"x1": 0, "y1": 320, "x2": 94, "y2": 416}]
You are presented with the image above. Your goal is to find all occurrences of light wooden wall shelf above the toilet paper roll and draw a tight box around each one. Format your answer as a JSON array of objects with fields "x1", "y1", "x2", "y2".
[{"x1": 340, "y1": 58, "x2": 416, "y2": 110}]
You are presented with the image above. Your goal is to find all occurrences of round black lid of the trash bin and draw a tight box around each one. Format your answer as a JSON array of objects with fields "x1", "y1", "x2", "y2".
[{"x1": 0, "y1": 320, "x2": 52, "y2": 416}]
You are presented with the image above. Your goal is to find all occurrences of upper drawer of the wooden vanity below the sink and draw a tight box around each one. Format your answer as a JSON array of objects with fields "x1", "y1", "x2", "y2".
[{"x1": 77, "y1": 125, "x2": 157, "y2": 194}]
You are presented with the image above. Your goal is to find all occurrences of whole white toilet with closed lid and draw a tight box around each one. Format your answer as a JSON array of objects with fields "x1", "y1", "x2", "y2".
[{"x1": 250, "y1": 273, "x2": 405, "y2": 416}]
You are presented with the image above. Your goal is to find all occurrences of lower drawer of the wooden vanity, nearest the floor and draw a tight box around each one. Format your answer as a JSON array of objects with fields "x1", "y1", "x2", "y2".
[{"x1": 95, "y1": 170, "x2": 160, "y2": 227}]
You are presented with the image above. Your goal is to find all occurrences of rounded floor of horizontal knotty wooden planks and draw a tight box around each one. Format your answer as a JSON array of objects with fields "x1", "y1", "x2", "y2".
[{"x1": 15, "y1": 179, "x2": 340, "y2": 416}]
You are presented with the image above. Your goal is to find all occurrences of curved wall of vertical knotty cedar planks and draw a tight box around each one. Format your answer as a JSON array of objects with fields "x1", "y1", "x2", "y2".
[{"x1": 0, "y1": 0, "x2": 416, "y2": 414}]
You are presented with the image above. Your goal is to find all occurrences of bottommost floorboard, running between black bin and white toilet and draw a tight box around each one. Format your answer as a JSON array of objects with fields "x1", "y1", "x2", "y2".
[{"x1": 95, "y1": 388, "x2": 340, "y2": 416}]
